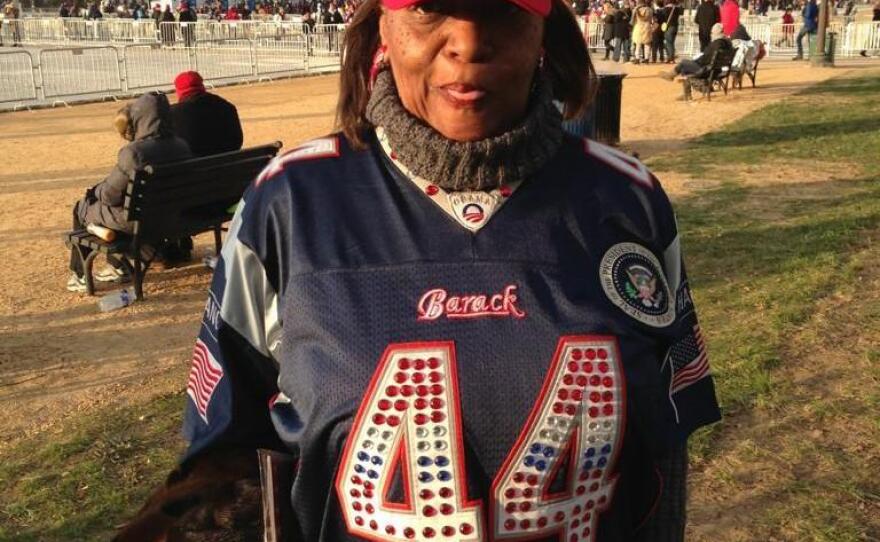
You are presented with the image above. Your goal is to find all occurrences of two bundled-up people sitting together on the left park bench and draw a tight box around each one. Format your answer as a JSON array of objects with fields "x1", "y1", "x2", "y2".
[{"x1": 67, "y1": 71, "x2": 244, "y2": 292}]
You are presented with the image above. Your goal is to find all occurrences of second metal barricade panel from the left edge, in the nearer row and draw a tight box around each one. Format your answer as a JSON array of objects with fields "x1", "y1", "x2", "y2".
[{"x1": 40, "y1": 47, "x2": 122, "y2": 98}]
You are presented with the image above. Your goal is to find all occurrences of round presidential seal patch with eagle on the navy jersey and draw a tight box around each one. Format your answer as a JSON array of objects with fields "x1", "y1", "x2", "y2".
[{"x1": 599, "y1": 243, "x2": 675, "y2": 327}]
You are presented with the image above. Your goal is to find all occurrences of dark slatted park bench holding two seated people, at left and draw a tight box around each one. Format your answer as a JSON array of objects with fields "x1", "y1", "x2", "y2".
[{"x1": 65, "y1": 141, "x2": 281, "y2": 300}]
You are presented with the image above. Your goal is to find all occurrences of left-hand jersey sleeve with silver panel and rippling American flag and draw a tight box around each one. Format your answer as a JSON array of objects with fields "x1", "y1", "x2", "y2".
[{"x1": 184, "y1": 189, "x2": 281, "y2": 459}]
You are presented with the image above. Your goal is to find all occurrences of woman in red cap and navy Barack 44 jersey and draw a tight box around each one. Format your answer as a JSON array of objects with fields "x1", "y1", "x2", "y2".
[{"x1": 113, "y1": 0, "x2": 719, "y2": 541}]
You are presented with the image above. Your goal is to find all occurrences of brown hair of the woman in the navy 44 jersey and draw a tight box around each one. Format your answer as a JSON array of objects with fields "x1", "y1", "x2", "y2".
[{"x1": 336, "y1": 0, "x2": 598, "y2": 148}]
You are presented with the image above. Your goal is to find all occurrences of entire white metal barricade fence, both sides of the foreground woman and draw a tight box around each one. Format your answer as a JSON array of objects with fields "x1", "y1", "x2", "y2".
[{"x1": 0, "y1": 19, "x2": 880, "y2": 108}]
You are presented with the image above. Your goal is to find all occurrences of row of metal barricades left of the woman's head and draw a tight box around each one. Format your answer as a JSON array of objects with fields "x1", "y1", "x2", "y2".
[{"x1": 0, "y1": 25, "x2": 344, "y2": 106}]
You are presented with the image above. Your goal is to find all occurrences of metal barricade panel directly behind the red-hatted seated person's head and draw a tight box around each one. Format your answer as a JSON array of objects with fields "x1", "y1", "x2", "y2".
[{"x1": 122, "y1": 43, "x2": 194, "y2": 91}]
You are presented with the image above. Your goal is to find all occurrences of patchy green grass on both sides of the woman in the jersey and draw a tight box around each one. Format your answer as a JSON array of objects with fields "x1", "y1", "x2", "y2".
[{"x1": 0, "y1": 73, "x2": 880, "y2": 542}]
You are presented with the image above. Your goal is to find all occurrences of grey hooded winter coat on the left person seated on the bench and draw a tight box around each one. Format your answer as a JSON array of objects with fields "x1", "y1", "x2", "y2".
[{"x1": 80, "y1": 93, "x2": 192, "y2": 232}]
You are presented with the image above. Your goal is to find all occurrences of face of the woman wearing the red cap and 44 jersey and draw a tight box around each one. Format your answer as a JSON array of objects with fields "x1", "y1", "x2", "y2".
[{"x1": 379, "y1": 0, "x2": 544, "y2": 141}]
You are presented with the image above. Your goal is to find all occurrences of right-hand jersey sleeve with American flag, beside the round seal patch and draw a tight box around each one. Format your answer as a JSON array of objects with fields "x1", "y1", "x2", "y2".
[{"x1": 655, "y1": 183, "x2": 721, "y2": 442}]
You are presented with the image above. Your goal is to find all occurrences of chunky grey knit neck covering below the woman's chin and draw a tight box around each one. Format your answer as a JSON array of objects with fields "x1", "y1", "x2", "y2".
[{"x1": 366, "y1": 70, "x2": 562, "y2": 191}]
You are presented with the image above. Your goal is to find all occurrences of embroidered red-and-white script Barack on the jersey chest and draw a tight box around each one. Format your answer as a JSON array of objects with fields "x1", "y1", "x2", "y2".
[{"x1": 418, "y1": 284, "x2": 526, "y2": 320}]
